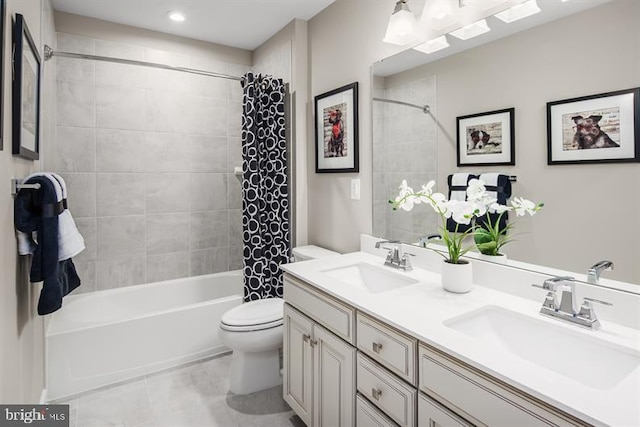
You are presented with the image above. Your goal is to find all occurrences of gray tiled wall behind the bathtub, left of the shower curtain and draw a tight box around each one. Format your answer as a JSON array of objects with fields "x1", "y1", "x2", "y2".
[{"x1": 51, "y1": 33, "x2": 248, "y2": 292}]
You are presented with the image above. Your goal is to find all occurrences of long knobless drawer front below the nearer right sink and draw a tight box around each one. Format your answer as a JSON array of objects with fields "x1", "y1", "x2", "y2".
[{"x1": 418, "y1": 343, "x2": 584, "y2": 427}]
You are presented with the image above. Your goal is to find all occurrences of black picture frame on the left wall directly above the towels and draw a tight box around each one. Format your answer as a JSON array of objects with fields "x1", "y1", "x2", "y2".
[{"x1": 12, "y1": 13, "x2": 40, "y2": 160}]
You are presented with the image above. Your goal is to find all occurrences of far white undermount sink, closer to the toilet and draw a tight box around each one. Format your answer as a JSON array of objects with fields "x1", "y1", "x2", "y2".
[{"x1": 323, "y1": 263, "x2": 418, "y2": 294}]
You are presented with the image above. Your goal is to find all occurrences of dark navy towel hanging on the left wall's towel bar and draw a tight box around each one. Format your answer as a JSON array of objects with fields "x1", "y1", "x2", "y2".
[{"x1": 14, "y1": 176, "x2": 80, "y2": 315}]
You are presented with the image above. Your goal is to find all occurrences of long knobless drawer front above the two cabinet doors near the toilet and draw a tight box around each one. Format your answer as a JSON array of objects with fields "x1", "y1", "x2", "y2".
[{"x1": 284, "y1": 274, "x2": 356, "y2": 345}]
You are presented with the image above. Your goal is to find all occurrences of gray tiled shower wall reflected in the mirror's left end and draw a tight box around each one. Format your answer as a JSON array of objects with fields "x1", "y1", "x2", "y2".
[{"x1": 373, "y1": 76, "x2": 440, "y2": 246}]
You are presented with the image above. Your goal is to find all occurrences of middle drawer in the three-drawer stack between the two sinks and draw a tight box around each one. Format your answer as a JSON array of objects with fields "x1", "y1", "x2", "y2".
[{"x1": 356, "y1": 353, "x2": 416, "y2": 427}]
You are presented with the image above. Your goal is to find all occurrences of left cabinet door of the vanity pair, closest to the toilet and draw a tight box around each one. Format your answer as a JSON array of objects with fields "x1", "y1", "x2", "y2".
[{"x1": 282, "y1": 304, "x2": 313, "y2": 426}]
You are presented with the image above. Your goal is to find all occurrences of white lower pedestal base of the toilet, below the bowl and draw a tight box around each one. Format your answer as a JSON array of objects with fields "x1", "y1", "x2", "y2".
[{"x1": 229, "y1": 348, "x2": 282, "y2": 395}]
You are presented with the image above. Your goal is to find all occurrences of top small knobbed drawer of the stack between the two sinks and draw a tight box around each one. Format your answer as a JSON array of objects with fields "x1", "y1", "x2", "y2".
[{"x1": 356, "y1": 312, "x2": 418, "y2": 386}]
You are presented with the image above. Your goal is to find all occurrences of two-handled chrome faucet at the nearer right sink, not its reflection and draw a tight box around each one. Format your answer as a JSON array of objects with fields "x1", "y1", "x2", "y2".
[{"x1": 533, "y1": 276, "x2": 612, "y2": 330}]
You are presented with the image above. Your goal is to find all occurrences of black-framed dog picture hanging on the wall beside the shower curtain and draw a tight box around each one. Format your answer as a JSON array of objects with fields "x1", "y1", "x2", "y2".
[{"x1": 315, "y1": 82, "x2": 358, "y2": 173}]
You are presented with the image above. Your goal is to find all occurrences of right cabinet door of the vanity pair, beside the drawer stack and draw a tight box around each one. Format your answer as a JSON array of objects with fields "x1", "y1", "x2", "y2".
[{"x1": 312, "y1": 324, "x2": 356, "y2": 427}]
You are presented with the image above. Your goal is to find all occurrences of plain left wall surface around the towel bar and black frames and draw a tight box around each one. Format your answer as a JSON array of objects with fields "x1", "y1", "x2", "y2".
[{"x1": 0, "y1": 0, "x2": 56, "y2": 403}]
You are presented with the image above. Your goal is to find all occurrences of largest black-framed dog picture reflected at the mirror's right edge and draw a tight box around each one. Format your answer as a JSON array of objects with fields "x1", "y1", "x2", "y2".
[{"x1": 547, "y1": 88, "x2": 640, "y2": 165}]
